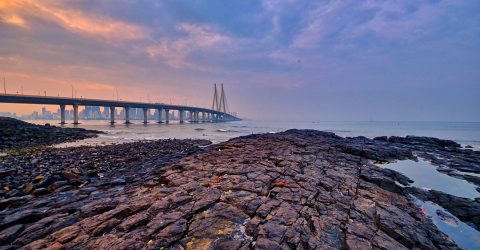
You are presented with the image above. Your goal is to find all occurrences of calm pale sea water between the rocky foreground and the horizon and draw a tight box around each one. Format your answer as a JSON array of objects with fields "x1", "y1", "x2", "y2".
[{"x1": 25, "y1": 120, "x2": 480, "y2": 150}]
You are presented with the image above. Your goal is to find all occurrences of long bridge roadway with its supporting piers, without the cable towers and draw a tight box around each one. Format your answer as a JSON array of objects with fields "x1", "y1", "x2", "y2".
[{"x1": 0, "y1": 94, "x2": 240, "y2": 124}]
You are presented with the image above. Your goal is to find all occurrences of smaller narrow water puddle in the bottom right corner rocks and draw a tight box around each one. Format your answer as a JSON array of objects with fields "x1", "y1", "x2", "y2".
[{"x1": 414, "y1": 197, "x2": 480, "y2": 249}]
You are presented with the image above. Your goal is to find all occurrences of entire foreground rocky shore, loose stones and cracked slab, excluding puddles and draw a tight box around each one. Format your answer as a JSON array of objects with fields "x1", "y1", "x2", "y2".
[{"x1": 0, "y1": 130, "x2": 480, "y2": 249}]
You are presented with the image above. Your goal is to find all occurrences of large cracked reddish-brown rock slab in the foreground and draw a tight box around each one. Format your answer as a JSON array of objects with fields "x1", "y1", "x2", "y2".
[{"x1": 0, "y1": 130, "x2": 478, "y2": 249}]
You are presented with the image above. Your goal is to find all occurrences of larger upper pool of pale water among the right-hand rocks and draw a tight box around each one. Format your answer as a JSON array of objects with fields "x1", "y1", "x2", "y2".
[{"x1": 380, "y1": 159, "x2": 480, "y2": 199}]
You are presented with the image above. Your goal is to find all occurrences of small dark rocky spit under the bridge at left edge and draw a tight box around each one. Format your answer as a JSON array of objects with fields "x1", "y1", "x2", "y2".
[{"x1": 0, "y1": 117, "x2": 101, "y2": 151}]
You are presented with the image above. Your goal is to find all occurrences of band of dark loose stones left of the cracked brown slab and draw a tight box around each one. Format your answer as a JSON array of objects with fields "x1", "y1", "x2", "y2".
[{"x1": 0, "y1": 140, "x2": 210, "y2": 203}]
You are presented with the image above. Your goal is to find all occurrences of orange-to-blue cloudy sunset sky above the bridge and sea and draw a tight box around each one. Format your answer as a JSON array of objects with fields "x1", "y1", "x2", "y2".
[{"x1": 0, "y1": 0, "x2": 480, "y2": 121}]
